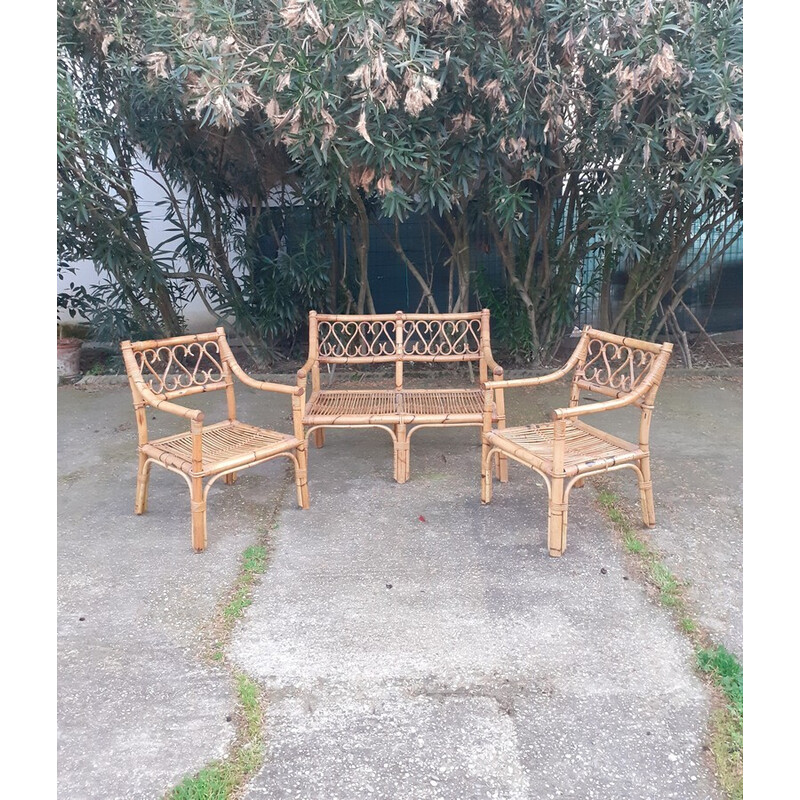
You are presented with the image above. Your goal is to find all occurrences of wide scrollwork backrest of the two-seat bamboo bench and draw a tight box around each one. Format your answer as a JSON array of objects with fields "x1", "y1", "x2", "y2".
[{"x1": 317, "y1": 314, "x2": 482, "y2": 364}]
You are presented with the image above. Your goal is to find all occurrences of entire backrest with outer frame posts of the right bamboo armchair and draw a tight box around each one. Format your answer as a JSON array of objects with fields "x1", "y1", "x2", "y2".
[{"x1": 571, "y1": 325, "x2": 672, "y2": 407}]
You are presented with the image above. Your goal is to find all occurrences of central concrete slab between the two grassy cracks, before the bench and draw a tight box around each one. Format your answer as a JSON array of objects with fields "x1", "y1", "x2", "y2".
[{"x1": 232, "y1": 372, "x2": 741, "y2": 800}]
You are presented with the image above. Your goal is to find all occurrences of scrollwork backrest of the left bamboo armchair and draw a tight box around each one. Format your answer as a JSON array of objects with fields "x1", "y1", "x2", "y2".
[{"x1": 128, "y1": 337, "x2": 230, "y2": 400}]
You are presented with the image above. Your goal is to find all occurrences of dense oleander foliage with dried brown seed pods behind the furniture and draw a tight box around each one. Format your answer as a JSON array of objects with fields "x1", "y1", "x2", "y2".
[{"x1": 58, "y1": 0, "x2": 743, "y2": 358}]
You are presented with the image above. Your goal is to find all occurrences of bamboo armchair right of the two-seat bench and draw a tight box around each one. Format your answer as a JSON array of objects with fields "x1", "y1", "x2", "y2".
[{"x1": 481, "y1": 325, "x2": 672, "y2": 556}]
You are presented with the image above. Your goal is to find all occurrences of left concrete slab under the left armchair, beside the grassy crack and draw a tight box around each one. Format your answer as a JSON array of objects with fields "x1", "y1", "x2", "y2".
[{"x1": 57, "y1": 386, "x2": 298, "y2": 800}]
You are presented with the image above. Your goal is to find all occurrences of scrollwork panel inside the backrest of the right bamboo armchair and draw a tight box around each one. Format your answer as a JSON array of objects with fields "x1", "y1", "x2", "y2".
[{"x1": 574, "y1": 331, "x2": 662, "y2": 404}]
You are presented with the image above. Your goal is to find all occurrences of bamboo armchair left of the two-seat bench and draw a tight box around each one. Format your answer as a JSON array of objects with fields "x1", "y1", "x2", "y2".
[{"x1": 121, "y1": 328, "x2": 308, "y2": 552}]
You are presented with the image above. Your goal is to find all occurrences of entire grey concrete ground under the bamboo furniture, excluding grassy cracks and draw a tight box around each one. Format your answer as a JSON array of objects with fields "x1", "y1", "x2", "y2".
[{"x1": 58, "y1": 370, "x2": 742, "y2": 800}]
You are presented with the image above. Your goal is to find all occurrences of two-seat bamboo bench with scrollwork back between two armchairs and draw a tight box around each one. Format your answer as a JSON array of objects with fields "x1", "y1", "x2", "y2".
[{"x1": 297, "y1": 309, "x2": 507, "y2": 483}]
